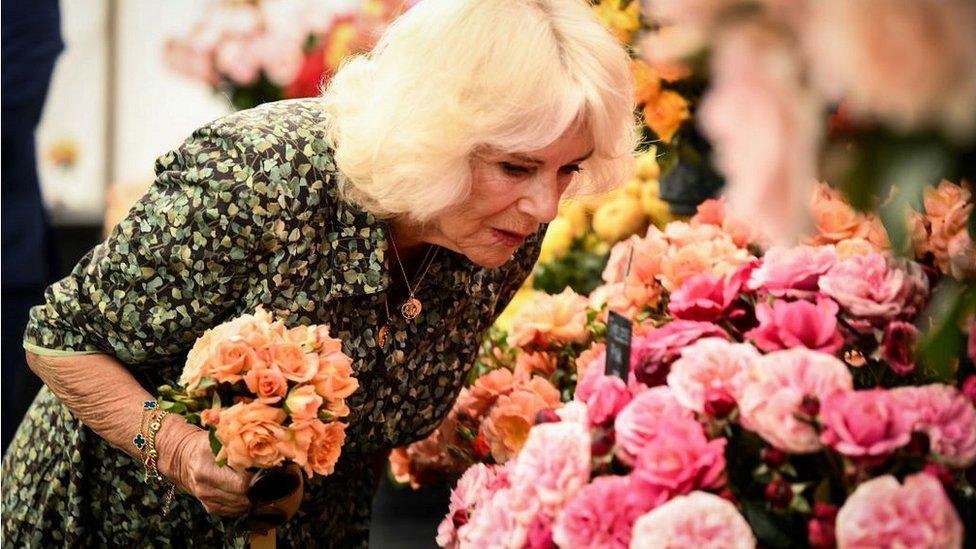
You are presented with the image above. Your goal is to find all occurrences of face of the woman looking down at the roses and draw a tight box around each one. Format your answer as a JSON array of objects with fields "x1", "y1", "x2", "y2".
[{"x1": 424, "y1": 125, "x2": 594, "y2": 267}]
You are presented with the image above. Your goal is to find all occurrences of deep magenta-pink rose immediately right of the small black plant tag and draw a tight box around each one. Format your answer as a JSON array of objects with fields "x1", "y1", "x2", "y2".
[{"x1": 630, "y1": 320, "x2": 728, "y2": 387}]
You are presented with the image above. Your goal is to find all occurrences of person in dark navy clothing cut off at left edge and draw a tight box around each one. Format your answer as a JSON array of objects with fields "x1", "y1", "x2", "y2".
[{"x1": 0, "y1": 0, "x2": 64, "y2": 450}]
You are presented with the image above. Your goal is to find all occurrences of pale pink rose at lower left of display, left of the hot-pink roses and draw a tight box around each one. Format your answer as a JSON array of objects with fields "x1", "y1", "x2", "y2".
[{"x1": 511, "y1": 421, "x2": 590, "y2": 513}]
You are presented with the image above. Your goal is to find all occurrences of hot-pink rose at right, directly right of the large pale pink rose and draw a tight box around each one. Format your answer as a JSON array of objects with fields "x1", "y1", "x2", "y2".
[{"x1": 820, "y1": 389, "x2": 913, "y2": 458}]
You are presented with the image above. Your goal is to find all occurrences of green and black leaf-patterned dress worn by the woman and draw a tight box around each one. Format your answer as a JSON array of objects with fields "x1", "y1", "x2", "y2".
[{"x1": 2, "y1": 99, "x2": 540, "y2": 548}]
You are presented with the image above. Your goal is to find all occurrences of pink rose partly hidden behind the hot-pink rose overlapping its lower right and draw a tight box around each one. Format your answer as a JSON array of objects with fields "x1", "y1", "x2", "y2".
[{"x1": 614, "y1": 386, "x2": 694, "y2": 464}]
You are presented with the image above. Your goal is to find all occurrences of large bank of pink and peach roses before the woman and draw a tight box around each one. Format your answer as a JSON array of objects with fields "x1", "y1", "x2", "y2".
[{"x1": 394, "y1": 181, "x2": 976, "y2": 547}]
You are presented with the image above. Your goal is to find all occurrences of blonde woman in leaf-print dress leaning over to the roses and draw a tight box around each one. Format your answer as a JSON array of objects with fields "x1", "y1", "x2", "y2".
[{"x1": 3, "y1": 0, "x2": 635, "y2": 547}]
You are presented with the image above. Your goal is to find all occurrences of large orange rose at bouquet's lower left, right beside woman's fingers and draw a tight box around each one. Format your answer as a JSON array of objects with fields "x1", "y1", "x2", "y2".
[{"x1": 216, "y1": 402, "x2": 287, "y2": 472}]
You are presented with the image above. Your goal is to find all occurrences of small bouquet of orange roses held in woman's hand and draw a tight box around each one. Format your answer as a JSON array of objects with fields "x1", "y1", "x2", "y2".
[{"x1": 159, "y1": 307, "x2": 359, "y2": 528}]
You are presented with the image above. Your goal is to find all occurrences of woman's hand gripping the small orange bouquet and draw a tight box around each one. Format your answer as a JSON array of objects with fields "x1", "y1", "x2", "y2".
[{"x1": 157, "y1": 418, "x2": 251, "y2": 517}]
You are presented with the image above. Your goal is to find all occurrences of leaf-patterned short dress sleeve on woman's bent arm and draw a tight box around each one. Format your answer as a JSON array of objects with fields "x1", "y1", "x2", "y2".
[{"x1": 24, "y1": 122, "x2": 267, "y2": 364}]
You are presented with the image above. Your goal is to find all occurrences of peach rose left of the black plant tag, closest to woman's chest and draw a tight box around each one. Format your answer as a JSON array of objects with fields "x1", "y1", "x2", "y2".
[{"x1": 508, "y1": 288, "x2": 586, "y2": 347}]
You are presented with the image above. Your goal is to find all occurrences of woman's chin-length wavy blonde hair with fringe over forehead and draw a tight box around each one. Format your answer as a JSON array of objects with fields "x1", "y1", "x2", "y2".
[{"x1": 323, "y1": 0, "x2": 637, "y2": 222}]
